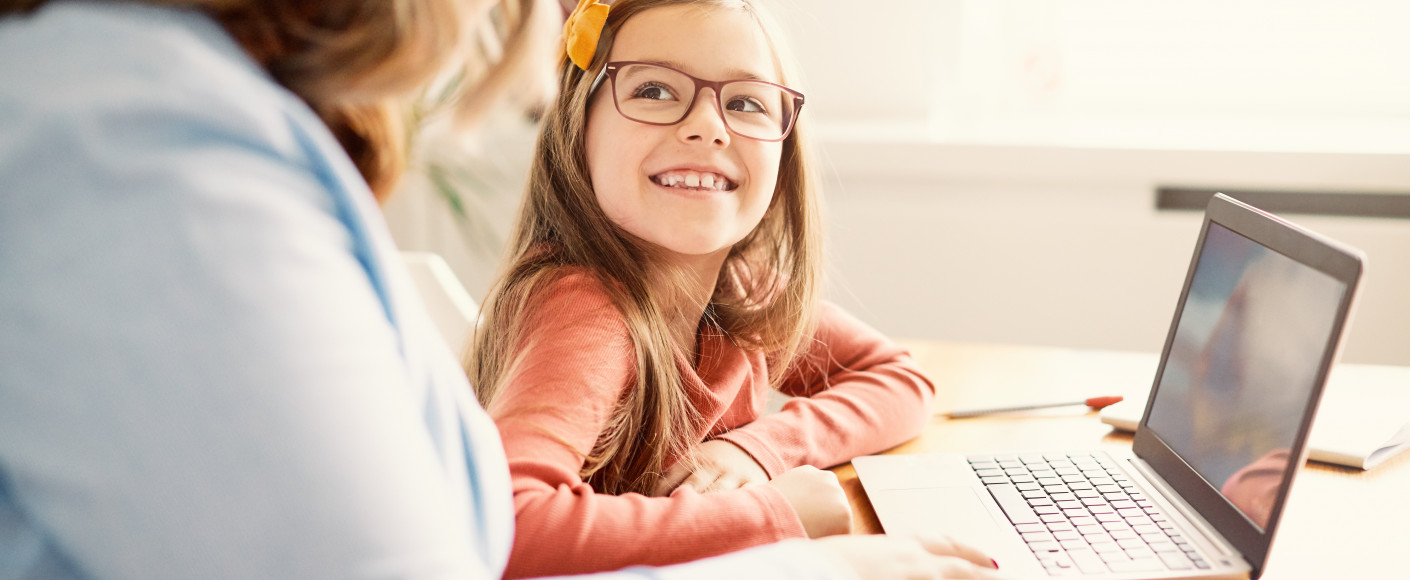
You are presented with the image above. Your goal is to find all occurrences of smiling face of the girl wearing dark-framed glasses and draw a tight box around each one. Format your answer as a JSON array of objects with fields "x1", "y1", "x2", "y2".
[{"x1": 587, "y1": 6, "x2": 783, "y2": 265}]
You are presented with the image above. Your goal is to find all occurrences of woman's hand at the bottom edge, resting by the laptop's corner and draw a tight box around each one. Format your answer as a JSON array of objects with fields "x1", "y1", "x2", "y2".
[{"x1": 815, "y1": 535, "x2": 1000, "y2": 580}]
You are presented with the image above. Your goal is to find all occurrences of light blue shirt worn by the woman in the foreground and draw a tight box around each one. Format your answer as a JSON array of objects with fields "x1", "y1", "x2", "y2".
[{"x1": 0, "y1": 3, "x2": 829, "y2": 579}]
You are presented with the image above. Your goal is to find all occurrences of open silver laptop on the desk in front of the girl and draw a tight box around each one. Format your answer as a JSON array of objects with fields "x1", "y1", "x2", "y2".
[{"x1": 852, "y1": 195, "x2": 1365, "y2": 579}]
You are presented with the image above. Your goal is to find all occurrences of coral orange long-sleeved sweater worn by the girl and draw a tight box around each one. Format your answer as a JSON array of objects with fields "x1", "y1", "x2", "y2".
[{"x1": 489, "y1": 274, "x2": 935, "y2": 577}]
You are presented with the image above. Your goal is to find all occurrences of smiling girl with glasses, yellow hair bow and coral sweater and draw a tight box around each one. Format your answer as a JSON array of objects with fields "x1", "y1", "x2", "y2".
[{"x1": 467, "y1": 0, "x2": 933, "y2": 577}]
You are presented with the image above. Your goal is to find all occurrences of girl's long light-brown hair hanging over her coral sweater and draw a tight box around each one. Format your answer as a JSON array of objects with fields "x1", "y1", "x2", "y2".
[{"x1": 465, "y1": 0, "x2": 822, "y2": 494}]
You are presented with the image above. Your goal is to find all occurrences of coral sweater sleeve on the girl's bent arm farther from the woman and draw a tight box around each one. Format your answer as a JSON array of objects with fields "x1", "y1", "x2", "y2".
[{"x1": 718, "y1": 303, "x2": 935, "y2": 477}]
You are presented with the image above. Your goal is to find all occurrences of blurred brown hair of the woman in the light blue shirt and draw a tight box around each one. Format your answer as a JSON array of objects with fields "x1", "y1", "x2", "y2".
[{"x1": 0, "y1": 0, "x2": 561, "y2": 202}]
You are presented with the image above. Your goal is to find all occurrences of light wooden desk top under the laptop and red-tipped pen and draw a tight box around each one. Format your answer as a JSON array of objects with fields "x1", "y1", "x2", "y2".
[{"x1": 835, "y1": 342, "x2": 1410, "y2": 580}]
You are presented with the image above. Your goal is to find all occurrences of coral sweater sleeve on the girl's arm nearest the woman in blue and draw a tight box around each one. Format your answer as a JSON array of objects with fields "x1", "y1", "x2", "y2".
[{"x1": 491, "y1": 274, "x2": 805, "y2": 577}]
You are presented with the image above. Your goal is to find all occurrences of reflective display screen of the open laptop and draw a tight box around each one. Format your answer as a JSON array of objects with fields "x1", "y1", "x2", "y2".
[{"x1": 1146, "y1": 222, "x2": 1347, "y2": 529}]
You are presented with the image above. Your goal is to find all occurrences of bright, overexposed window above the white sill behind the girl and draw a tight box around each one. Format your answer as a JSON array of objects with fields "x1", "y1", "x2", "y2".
[{"x1": 785, "y1": 0, "x2": 1410, "y2": 152}]
